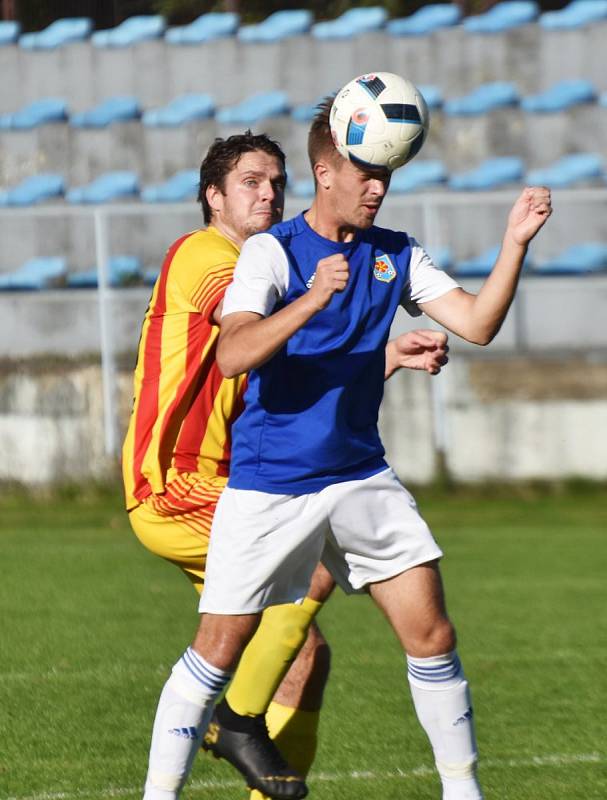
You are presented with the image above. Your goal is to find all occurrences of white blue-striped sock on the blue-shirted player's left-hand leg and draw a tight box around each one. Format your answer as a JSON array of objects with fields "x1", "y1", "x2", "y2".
[{"x1": 143, "y1": 647, "x2": 231, "y2": 800}]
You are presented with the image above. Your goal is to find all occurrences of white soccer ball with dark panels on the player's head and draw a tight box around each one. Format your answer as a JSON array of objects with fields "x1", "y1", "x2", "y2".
[{"x1": 329, "y1": 72, "x2": 429, "y2": 170}]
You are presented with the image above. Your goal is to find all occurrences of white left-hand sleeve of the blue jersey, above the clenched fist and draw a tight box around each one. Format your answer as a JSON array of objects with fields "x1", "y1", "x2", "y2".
[{"x1": 221, "y1": 233, "x2": 289, "y2": 317}]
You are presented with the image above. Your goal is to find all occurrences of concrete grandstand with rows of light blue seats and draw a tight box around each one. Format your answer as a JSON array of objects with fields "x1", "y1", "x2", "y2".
[{"x1": 0, "y1": 0, "x2": 607, "y2": 482}]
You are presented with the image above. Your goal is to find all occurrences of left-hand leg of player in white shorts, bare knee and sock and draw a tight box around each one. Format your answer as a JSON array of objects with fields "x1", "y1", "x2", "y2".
[{"x1": 144, "y1": 614, "x2": 259, "y2": 800}]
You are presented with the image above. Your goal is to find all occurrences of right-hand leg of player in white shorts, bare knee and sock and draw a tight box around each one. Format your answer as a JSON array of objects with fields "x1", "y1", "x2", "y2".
[{"x1": 369, "y1": 562, "x2": 483, "y2": 800}]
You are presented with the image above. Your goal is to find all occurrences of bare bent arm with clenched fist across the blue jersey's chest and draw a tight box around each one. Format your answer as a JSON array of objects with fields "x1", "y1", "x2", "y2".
[{"x1": 217, "y1": 254, "x2": 349, "y2": 378}]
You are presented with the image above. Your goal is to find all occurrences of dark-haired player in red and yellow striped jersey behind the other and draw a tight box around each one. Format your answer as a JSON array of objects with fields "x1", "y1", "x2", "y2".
[{"x1": 122, "y1": 134, "x2": 332, "y2": 797}]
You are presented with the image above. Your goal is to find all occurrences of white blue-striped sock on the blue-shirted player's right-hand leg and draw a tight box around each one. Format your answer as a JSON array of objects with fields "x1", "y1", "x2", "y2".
[{"x1": 407, "y1": 651, "x2": 483, "y2": 800}]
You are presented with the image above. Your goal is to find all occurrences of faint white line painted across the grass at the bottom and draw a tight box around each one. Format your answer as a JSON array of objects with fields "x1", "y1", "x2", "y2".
[{"x1": 6, "y1": 753, "x2": 607, "y2": 800}]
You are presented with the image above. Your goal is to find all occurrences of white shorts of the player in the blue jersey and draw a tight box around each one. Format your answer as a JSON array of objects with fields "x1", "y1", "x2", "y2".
[{"x1": 199, "y1": 469, "x2": 442, "y2": 614}]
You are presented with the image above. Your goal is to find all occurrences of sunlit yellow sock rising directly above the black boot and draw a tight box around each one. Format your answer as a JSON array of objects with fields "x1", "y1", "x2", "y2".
[{"x1": 226, "y1": 597, "x2": 322, "y2": 716}]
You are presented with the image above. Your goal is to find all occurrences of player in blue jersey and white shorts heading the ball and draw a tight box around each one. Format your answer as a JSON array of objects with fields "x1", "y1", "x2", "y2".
[{"x1": 141, "y1": 102, "x2": 551, "y2": 800}]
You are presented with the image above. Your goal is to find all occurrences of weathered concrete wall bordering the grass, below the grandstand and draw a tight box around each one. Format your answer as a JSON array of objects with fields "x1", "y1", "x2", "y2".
[{"x1": 0, "y1": 355, "x2": 607, "y2": 485}]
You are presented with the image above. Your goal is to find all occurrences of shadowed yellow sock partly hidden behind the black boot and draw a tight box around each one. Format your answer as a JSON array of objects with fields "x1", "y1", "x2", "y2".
[{"x1": 250, "y1": 703, "x2": 320, "y2": 800}]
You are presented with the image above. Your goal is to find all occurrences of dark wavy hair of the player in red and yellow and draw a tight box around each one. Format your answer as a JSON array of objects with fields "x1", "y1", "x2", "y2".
[{"x1": 198, "y1": 130, "x2": 286, "y2": 225}]
